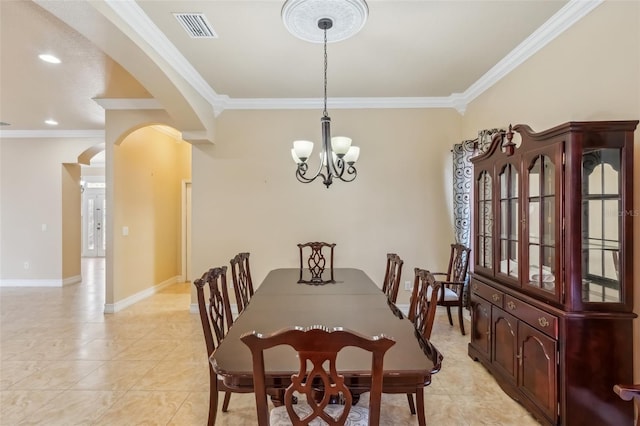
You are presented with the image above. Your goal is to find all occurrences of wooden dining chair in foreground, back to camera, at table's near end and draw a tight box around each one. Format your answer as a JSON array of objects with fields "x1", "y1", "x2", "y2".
[{"x1": 241, "y1": 326, "x2": 395, "y2": 426}]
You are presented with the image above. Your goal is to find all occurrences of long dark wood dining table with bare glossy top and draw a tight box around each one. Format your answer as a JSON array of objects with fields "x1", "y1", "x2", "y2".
[{"x1": 210, "y1": 268, "x2": 443, "y2": 425}]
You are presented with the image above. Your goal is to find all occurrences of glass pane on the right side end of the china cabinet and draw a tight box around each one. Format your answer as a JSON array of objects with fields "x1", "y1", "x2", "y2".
[{"x1": 582, "y1": 148, "x2": 625, "y2": 303}]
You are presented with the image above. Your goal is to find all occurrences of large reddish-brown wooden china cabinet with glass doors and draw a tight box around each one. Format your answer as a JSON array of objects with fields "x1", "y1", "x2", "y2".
[{"x1": 469, "y1": 121, "x2": 640, "y2": 426}]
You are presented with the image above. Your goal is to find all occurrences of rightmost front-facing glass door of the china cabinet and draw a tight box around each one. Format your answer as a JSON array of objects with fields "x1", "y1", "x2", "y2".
[{"x1": 523, "y1": 155, "x2": 556, "y2": 293}]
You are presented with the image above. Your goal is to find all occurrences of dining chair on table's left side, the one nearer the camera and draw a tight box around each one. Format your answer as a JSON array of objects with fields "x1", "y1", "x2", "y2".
[{"x1": 193, "y1": 266, "x2": 238, "y2": 426}]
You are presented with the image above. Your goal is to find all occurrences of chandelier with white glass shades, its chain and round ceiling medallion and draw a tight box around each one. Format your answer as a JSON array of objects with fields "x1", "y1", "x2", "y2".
[{"x1": 282, "y1": 0, "x2": 369, "y2": 188}]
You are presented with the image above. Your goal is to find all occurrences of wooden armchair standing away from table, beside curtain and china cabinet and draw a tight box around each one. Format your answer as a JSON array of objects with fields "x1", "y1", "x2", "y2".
[{"x1": 433, "y1": 244, "x2": 471, "y2": 336}]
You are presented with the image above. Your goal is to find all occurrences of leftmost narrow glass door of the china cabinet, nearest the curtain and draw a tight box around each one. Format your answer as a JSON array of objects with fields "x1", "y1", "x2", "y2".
[{"x1": 476, "y1": 171, "x2": 493, "y2": 269}]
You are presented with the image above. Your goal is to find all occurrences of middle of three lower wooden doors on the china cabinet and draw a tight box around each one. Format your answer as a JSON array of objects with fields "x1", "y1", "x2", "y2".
[{"x1": 491, "y1": 306, "x2": 518, "y2": 384}]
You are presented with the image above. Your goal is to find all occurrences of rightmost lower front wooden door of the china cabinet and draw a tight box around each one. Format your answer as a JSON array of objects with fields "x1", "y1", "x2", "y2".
[{"x1": 518, "y1": 322, "x2": 556, "y2": 423}]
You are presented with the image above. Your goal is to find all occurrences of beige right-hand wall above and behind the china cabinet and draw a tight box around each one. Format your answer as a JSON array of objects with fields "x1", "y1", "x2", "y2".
[{"x1": 463, "y1": 1, "x2": 640, "y2": 382}]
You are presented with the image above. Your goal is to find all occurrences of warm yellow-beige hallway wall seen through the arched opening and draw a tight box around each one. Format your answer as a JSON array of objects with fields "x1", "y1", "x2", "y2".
[{"x1": 108, "y1": 127, "x2": 191, "y2": 303}]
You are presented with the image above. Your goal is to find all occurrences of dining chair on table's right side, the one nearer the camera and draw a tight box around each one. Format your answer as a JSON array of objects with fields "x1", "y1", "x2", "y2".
[{"x1": 407, "y1": 268, "x2": 441, "y2": 416}]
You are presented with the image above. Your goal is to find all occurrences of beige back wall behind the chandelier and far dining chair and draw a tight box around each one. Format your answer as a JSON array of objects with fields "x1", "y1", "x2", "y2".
[{"x1": 192, "y1": 108, "x2": 461, "y2": 303}]
